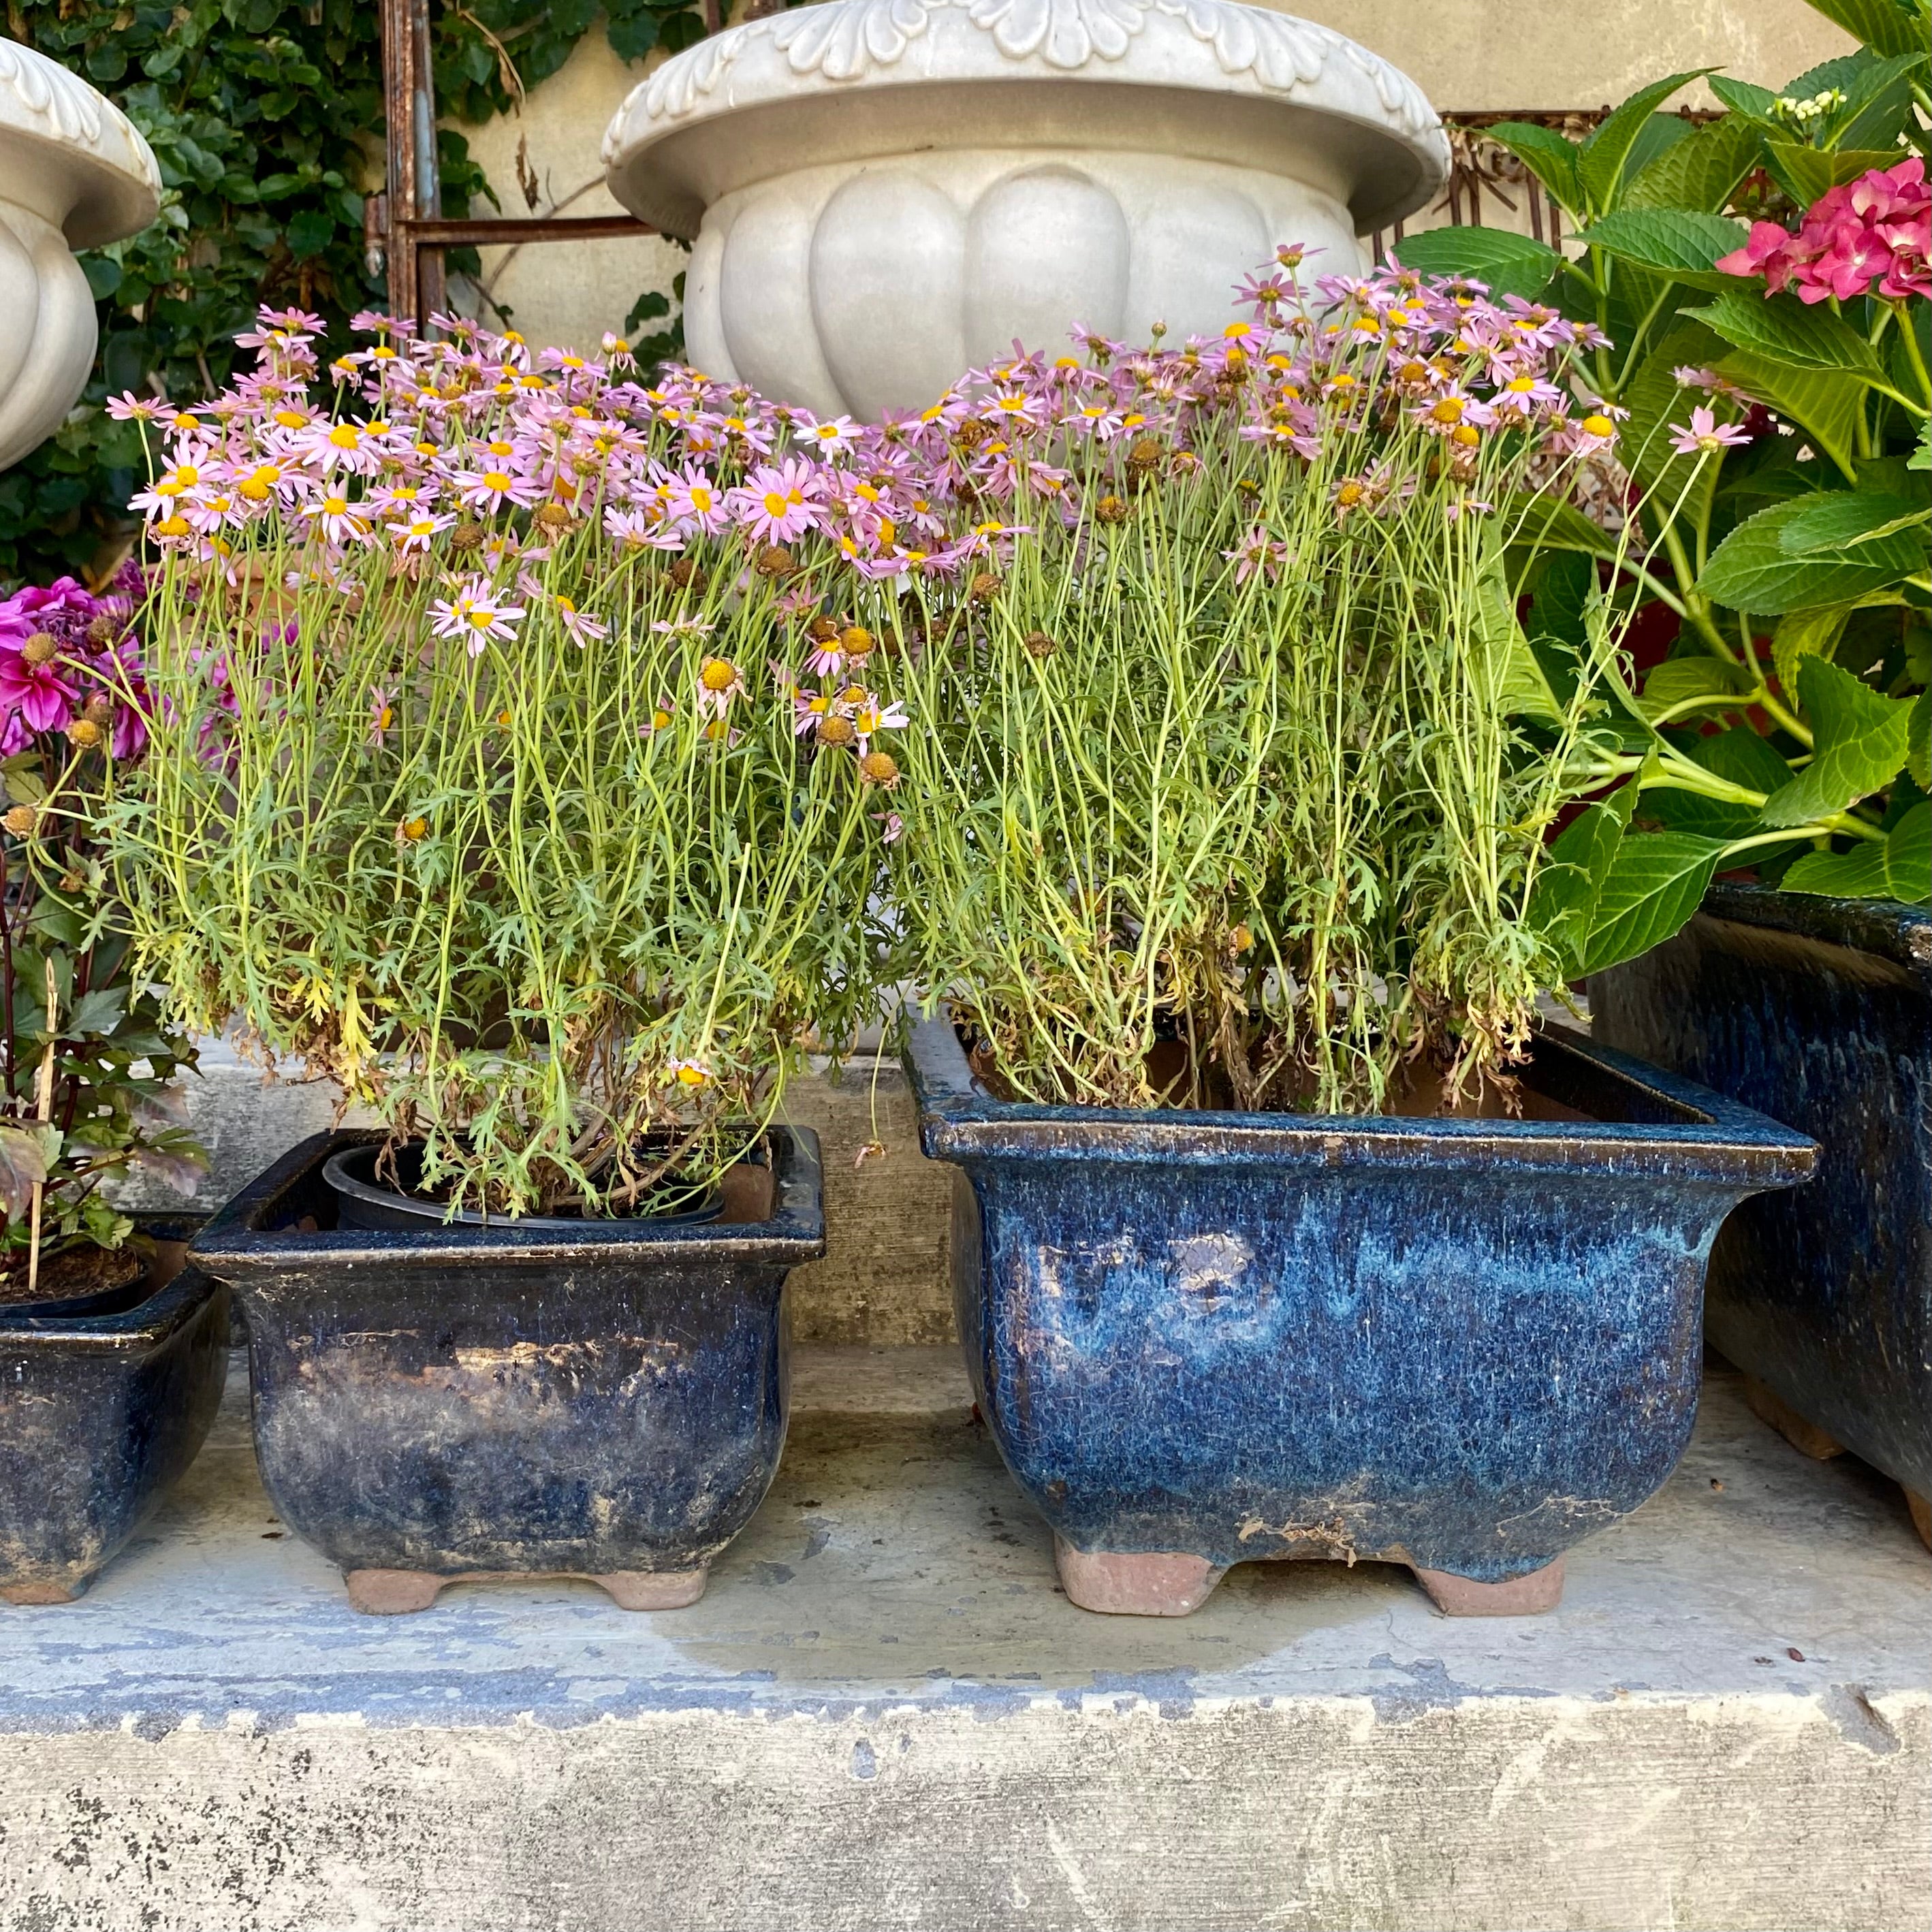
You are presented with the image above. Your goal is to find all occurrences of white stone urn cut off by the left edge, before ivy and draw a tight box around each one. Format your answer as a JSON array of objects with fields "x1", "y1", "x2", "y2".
[{"x1": 0, "y1": 41, "x2": 160, "y2": 469}]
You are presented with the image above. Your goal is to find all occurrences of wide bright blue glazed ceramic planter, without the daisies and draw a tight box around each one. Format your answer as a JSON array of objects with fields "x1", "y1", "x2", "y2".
[{"x1": 908, "y1": 1020, "x2": 1814, "y2": 1615}]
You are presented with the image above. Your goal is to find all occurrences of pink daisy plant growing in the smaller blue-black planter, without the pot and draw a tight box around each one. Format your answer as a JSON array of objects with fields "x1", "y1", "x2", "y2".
[{"x1": 102, "y1": 311, "x2": 898, "y2": 1215}]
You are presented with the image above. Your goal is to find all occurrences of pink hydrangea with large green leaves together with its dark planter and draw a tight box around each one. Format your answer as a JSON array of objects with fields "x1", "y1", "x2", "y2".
[{"x1": 1403, "y1": 0, "x2": 1932, "y2": 1530}]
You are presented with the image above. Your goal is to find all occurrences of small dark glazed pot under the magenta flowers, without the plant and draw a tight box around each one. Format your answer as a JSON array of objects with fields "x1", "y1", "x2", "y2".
[{"x1": 0, "y1": 1242, "x2": 228, "y2": 1604}]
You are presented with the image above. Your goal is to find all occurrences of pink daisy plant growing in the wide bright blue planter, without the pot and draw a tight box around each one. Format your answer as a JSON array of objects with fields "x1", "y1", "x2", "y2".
[{"x1": 876, "y1": 249, "x2": 1677, "y2": 1113}]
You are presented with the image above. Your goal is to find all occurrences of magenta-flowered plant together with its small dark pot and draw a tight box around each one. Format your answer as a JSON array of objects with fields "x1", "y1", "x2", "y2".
[{"x1": 0, "y1": 572, "x2": 228, "y2": 1604}]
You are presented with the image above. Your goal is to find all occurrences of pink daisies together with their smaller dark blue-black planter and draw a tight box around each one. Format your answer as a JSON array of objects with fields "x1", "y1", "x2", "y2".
[{"x1": 108, "y1": 313, "x2": 891, "y2": 1611}]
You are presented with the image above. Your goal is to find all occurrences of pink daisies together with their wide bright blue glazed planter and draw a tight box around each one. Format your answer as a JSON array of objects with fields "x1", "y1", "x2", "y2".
[{"x1": 869, "y1": 249, "x2": 1812, "y2": 1615}]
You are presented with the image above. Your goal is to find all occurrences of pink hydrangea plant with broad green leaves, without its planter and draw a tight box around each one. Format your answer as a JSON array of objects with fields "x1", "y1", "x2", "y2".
[{"x1": 1399, "y1": 0, "x2": 1932, "y2": 974}]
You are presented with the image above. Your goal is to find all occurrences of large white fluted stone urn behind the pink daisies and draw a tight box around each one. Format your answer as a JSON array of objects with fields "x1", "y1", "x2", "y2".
[{"x1": 605, "y1": 0, "x2": 1449, "y2": 417}]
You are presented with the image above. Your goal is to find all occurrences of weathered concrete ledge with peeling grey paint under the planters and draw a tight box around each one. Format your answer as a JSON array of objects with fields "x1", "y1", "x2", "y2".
[{"x1": 0, "y1": 1350, "x2": 1932, "y2": 1932}]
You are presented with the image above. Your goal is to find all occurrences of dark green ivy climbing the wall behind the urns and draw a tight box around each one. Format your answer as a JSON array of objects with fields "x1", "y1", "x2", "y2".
[{"x1": 0, "y1": 0, "x2": 703, "y2": 582}]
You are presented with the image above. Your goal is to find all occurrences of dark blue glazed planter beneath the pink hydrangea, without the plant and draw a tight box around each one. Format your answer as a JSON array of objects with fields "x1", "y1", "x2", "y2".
[{"x1": 1590, "y1": 885, "x2": 1932, "y2": 1542}]
